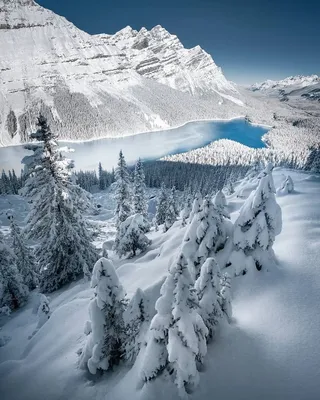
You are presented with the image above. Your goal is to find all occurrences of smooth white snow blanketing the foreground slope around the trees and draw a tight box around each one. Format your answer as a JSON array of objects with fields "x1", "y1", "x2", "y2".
[{"x1": 0, "y1": 168, "x2": 320, "y2": 400}]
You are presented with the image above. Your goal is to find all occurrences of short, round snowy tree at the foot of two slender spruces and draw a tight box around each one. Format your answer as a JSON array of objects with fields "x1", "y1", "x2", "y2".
[{"x1": 114, "y1": 214, "x2": 151, "y2": 257}]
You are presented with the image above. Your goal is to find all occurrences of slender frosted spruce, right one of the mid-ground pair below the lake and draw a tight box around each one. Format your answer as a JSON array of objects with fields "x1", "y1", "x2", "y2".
[{"x1": 133, "y1": 158, "x2": 148, "y2": 218}]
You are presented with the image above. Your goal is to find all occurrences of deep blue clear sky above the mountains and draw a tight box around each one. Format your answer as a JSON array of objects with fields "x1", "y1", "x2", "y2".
[{"x1": 36, "y1": 0, "x2": 320, "y2": 84}]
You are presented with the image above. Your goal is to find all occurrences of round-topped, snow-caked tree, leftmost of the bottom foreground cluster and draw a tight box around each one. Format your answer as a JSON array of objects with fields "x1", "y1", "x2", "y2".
[{"x1": 80, "y1": 258, "x2": 126, "y2": 374}]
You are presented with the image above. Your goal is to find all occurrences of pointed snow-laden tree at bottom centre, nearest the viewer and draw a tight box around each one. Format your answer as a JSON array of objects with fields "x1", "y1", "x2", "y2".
[{"x1": 141, "y1": 254, "x2": 208, "y2": 397}]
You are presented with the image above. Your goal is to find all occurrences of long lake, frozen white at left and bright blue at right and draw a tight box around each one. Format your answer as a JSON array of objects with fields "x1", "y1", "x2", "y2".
[{"x1": 0, "y1": 119, "x2": 268, "y2": 171}]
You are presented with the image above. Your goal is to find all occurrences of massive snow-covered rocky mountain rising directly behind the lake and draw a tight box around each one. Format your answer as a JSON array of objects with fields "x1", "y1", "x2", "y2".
[{"x1": 0, "y1": 0, "x2": 243, "y2": 145}]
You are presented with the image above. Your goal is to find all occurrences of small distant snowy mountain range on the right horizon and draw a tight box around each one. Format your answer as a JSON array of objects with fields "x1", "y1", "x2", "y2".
[{"x1": 251, "y1": 75, "x2": 320, "y2": 95}]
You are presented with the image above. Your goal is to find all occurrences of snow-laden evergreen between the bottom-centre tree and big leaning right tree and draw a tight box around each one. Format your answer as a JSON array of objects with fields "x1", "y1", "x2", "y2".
[{"x1": 182, "y1": 196, "x2": 228, "y2": 279}]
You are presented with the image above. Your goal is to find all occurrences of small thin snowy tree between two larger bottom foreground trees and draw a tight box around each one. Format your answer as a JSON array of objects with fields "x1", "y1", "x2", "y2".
[{"x1": 123, "y1": 288, "x2": 149, "y2": 364}]
